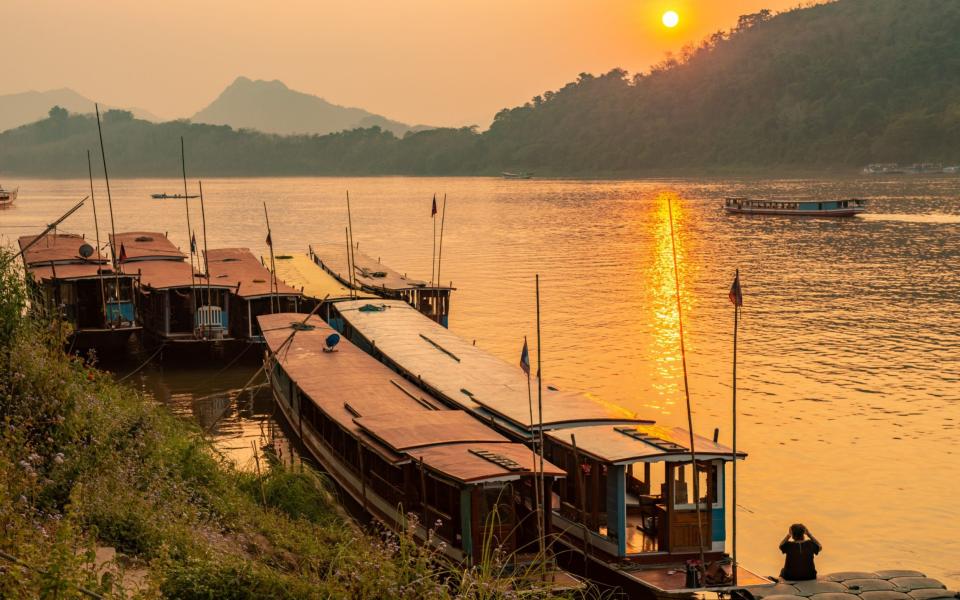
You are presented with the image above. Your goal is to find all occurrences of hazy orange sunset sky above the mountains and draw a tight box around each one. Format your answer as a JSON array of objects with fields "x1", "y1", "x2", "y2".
[{"x1": 0, "y1": 0, "x2": 799, "y2": 126}]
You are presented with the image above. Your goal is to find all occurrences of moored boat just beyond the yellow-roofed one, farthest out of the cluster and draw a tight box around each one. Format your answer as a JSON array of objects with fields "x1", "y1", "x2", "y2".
[{"x1": 310, "y1": 244, "x2": 456, "y2": 327}]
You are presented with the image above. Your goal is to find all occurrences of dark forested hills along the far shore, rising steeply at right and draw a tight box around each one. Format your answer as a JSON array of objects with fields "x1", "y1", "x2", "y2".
[{"x1": 0, "y1": 0, "x2": 960, "y2": 176}]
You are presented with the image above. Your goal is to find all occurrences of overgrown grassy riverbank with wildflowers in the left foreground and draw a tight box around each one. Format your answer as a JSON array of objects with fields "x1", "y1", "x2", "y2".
[{"x1": 0, "y1": 251, "x2": 572, "y2": 599}]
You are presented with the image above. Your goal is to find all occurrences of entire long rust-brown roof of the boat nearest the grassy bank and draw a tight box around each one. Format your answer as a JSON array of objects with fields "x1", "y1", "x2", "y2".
[{"x1": 257, "y1": 313, "x2": 562, "y2": 482}]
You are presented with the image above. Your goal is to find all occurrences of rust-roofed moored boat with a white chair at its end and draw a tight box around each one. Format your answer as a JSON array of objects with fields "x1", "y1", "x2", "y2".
[{"x1": 110, "y1": 231, "x2": 234, "y2": 349}]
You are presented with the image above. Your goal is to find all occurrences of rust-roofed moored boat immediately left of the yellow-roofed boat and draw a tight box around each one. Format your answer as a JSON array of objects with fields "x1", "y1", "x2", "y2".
[{"x1": 201, "y1": 248, "x2": 300, "y2": 343}]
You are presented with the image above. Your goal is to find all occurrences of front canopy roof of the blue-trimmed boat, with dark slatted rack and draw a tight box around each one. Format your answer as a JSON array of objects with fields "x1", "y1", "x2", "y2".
[{"x1": 546, "y1": 424, "x2": 747, "y2": 464}]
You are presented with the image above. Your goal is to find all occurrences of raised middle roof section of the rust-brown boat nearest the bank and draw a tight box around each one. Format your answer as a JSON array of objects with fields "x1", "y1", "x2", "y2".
[{"x1": 355, "y1": 410, "x2": 509, "y2": 451}]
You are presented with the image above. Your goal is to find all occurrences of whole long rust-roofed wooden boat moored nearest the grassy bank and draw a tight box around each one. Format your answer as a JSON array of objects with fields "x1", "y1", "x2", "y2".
[{"x1": 258, "y1": 314, "x2": 577, "y2": 587}]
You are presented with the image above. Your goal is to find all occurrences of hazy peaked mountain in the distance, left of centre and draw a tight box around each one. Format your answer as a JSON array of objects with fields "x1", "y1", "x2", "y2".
[{"x1": 190, "y1": 77, "x2": 429, "y2": 136}]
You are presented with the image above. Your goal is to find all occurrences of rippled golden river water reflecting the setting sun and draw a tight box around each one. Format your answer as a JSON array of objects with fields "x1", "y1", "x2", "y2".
[{"x1": 0, "y1": 176, "x2": 960, "y2": 586}]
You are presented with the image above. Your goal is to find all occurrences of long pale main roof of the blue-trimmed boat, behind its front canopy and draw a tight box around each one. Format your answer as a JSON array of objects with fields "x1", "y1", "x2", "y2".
[{"x1": 335, "y1": 300, "x2": 645, "y2": 431}]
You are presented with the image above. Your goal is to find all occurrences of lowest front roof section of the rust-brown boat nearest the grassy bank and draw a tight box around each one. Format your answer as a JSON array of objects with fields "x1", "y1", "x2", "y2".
[{"x1": 409, "y1": 442, "x2": 566, "y2": 483}]
